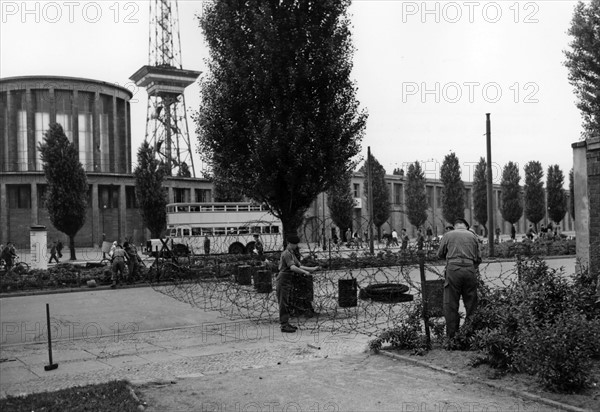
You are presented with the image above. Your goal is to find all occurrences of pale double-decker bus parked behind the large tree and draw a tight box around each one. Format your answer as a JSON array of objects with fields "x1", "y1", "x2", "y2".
[{"x1": 167, "y1": 202, "x2": 283, "y2": 254}]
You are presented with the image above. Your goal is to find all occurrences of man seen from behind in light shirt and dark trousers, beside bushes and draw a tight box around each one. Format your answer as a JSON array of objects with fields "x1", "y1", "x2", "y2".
[{"x1": 438, "y1": 218, "x2": 481, "y2": 338}]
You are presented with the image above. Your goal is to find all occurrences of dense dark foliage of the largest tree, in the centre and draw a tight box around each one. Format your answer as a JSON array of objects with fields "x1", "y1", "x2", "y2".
[{"x1": 195, "y1": 0, "x2": 366, "y2": 238}]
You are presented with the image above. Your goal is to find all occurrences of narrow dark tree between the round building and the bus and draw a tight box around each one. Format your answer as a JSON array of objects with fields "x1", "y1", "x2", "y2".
[{"x1": 133, "y1": 140, "x2": 167, "y2": 238}]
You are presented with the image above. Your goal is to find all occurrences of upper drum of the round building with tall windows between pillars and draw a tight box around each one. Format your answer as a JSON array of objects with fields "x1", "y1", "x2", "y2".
[{"x1": 0, "y1": 76, "x2": 132, "y2": 173}]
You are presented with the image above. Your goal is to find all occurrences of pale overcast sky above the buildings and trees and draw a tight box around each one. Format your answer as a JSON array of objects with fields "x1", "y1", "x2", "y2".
[{"x1": 0, "y1": 0, "x2": 581, "y2": 182}]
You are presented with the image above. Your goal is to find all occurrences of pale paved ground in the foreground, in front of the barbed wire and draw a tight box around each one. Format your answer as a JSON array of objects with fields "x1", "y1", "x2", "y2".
[{"x1": 0, "y1": 288, "x2": 580, "y2": 412}]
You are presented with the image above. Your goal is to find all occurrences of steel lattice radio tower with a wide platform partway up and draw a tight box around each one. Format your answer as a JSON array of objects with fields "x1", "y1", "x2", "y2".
[{"x1": 130, "y1": 0, "x2": 200, "y2": 177}]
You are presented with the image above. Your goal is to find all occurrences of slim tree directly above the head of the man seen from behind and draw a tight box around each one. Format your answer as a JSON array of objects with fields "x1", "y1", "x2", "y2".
[{"x1": 440, "y1": 152, "x2": 465, "y2": 223}]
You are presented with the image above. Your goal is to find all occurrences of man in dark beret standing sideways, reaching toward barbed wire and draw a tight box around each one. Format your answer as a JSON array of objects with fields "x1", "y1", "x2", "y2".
[{"x1": 275, "y1": 234, "x2": 318, "y2": 333}]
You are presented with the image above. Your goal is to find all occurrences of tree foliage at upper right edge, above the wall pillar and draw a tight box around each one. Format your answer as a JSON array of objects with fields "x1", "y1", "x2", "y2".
[{"x1": 565, "y1": 0, "x2": 600, "y2": 137}]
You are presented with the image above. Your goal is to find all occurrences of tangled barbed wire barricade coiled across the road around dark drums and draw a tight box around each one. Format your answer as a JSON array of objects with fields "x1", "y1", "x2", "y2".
[{"x1": 146, "y1": 219, "x2": 544, "y2": 336}]
